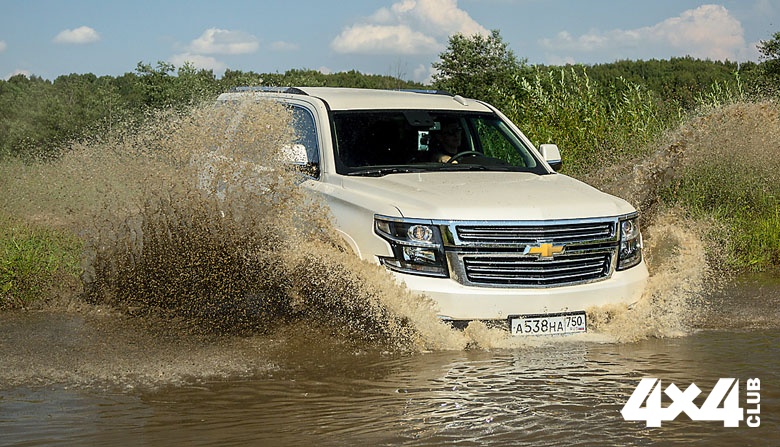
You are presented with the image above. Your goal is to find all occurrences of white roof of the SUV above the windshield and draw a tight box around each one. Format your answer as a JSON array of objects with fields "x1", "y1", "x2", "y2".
[{"x1": 220, "y1": 87, "x2": 491, "y2": 112}]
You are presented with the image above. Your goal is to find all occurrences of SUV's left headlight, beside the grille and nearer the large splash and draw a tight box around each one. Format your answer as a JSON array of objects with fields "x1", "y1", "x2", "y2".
[{"x1": 374, "y1": 216, "x2": 448, "y2": 277}]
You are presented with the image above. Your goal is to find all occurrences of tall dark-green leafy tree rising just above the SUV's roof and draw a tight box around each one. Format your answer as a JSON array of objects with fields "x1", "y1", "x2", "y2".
[{"x1": 432, "y1": 30, "x2": 526, "y2": 106}]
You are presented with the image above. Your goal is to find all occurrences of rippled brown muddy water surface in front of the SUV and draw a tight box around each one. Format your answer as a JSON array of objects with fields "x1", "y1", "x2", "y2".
[{"x1": 0, "y1": 277, "x2": 780, "y2": 446}]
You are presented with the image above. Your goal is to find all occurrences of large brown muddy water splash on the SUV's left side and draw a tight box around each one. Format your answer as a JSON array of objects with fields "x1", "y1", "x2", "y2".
[{"x1": 61, "y1": 103, "x2": 465, "y2": 350}]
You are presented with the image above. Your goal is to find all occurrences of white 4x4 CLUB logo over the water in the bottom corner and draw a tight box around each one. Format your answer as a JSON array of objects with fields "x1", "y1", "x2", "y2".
[{"x1": 620, "y1": 378, "x2": 761, "y2": 427}]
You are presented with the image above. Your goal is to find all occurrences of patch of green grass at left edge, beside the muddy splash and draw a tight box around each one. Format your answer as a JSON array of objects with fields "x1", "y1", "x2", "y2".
[{"x1": 0, "y1": 219, "x2": 82, "y2": 309}]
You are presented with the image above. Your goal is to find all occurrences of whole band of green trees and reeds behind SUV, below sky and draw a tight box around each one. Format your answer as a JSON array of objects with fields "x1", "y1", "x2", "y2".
[{"x1": 0, "y1": 41, "x2": 775, "y2": 164}]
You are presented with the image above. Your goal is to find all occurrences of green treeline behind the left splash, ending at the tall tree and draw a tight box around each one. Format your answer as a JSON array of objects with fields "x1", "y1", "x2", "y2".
[{"x1": 0, "y1": 62, "x2": 422, "y2": 158}]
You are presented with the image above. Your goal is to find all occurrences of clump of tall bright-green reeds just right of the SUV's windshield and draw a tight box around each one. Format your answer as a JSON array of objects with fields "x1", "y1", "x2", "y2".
[{"x1": 507, "y1": 68, "x2": 680, "y2": 175}]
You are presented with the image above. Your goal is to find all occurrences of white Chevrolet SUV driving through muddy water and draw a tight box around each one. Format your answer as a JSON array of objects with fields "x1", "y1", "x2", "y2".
[{"x1": 218, "y1": 87, "x2": 648, "y2": 335}]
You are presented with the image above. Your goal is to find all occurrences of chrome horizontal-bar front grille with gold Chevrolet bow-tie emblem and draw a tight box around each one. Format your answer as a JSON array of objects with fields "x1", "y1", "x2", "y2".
[{"x1": 442, "y1": 219, "x2": 618, "y2": 288}]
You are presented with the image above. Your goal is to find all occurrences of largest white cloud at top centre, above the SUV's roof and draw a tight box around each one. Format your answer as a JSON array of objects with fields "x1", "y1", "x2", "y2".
[{"x1": 331, "y1": 0, "x2": 489, "y2": 55}]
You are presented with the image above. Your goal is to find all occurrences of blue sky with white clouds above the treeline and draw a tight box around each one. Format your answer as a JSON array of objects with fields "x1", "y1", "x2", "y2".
[{"x1": 0, "y1": 0, "x2": 780, "y2": 82}]
